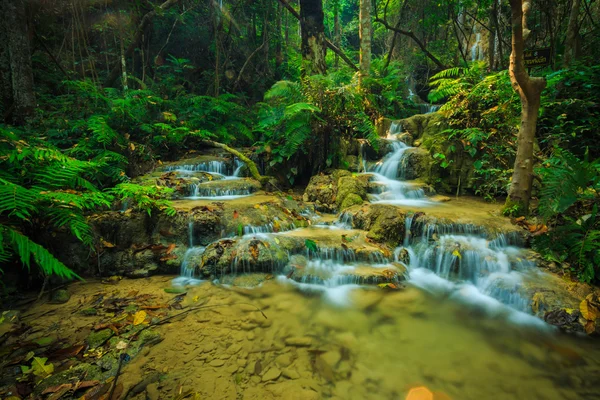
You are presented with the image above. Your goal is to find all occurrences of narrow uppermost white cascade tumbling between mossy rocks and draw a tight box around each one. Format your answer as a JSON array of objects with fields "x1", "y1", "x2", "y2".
[{"x1": 370, "y1": 122, "x2": 431, "y2": 206}]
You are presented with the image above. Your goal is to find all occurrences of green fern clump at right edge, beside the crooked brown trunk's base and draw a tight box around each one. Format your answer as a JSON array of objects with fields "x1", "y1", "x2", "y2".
[{"x1": 534, "y1": 148, "x2": 600, "y2": 282}]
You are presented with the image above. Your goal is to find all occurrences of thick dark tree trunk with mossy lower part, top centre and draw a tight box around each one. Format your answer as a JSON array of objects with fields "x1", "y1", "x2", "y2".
[{"x1": 300, "y1": 0, "x2": 327, "y2": 76}]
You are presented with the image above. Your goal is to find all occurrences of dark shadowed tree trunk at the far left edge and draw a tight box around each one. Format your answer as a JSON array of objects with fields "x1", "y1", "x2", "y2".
[{"x1": 0, "y1": 0, "x2": 36, "y2": 125}]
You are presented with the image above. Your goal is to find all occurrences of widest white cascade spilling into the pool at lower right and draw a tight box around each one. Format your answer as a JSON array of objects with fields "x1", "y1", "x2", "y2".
[{"x1": 395, "y1": 216, "x2": 542, "y2": 324}]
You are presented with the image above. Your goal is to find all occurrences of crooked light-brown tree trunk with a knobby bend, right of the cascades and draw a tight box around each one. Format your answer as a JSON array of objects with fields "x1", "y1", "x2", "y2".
[{"x1": 505, "y1": 0, "x2": 546, "y2": 214}]
